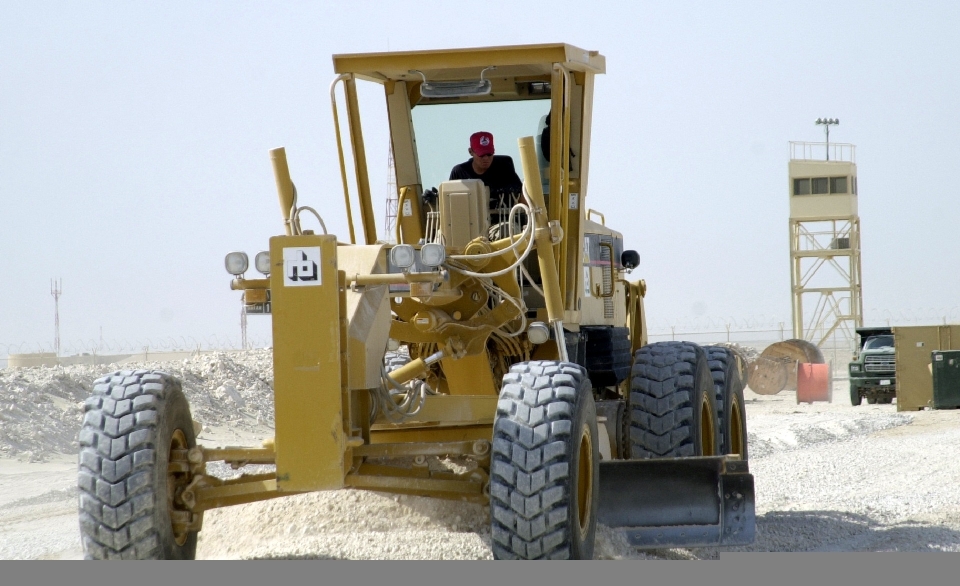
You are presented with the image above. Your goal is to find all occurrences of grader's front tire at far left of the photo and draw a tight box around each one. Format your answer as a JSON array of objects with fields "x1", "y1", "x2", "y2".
[{"x1": 78, "y1": 370, "x2": 197, "y2": 560}]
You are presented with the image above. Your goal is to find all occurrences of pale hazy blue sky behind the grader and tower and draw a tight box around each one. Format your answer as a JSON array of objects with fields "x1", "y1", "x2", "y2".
[{"x1": 0, "y1": 0, "x2": 960, "y2": 358}]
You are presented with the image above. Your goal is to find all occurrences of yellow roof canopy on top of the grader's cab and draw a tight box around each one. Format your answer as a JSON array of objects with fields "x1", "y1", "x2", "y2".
[{"x1": 333, "y1": 43, "x2": 606, "y2": 83}]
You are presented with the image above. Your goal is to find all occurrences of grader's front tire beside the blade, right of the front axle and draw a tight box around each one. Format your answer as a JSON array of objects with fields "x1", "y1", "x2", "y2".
[{"x1": 490, "y1": 361, "x2": 600, "y2": 559}]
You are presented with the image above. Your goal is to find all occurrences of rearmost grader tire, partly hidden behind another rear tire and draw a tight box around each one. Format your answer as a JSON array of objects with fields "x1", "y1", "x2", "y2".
[{"x1": 703, "y1": 346, "x2": 747, "y2": 460}]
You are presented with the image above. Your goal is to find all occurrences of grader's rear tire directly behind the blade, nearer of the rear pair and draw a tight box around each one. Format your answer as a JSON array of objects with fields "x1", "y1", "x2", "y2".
[{"x1": 629, "y1": 342, "x2": 719, "y2": 460}]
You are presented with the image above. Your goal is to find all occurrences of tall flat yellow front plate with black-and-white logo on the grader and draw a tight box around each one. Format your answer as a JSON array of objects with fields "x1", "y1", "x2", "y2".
[{"x1": 270, "y1": 235, "x2": 346, "y2": 492}]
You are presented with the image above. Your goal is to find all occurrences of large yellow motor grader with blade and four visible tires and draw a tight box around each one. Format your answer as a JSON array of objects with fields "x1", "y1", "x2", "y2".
[{"x1": 78, "y1": 44, "x2": 755, "y2": 559}]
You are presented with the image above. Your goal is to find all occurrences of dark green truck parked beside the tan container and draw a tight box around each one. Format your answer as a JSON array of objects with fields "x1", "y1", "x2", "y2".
[{"x1": 847, "y1": 328, "x2": 897, "y2": 407}]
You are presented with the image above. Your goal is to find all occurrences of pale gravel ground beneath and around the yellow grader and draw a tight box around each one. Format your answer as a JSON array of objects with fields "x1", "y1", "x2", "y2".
[{"x1": 0, "y1": 351, "x2": 960, "y2": 559}]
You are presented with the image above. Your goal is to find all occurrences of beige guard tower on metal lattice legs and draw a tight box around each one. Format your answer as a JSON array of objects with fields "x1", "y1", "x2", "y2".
[{"x1": 788, "y1": 137, "x2": 863, "y2": 351}]
